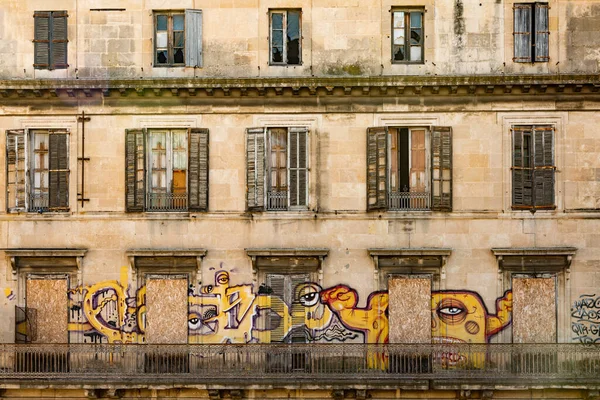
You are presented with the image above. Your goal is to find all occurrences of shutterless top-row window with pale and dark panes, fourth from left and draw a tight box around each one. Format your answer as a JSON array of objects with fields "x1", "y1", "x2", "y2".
[{"x1": 392, "y1": 9, "x2": 425, "y2": 63}]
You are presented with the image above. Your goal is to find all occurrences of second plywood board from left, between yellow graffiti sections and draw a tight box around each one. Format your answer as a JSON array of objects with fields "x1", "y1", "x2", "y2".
[{"x1": 146, "y1": 279, "x2": 188, "y2": 344}]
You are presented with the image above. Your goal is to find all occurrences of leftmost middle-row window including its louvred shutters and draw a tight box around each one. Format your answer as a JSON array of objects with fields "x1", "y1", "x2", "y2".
[{"x1": 6, "y1": 129, "x2": 69, "y2": 212}]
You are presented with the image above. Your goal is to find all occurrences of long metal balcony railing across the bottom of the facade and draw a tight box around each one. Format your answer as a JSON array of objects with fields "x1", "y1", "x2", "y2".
[{"x1": 0, "y1": 344, "x2": 600, "y2": 385}]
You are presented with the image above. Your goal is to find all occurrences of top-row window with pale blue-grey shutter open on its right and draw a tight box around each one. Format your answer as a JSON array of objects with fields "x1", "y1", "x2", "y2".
[{"x1": 154, "y1": 10, "x2": 202, "y2": 67}]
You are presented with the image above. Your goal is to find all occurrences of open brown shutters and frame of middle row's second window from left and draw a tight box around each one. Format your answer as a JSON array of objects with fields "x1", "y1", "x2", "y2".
[{"x1": 125, "y1": 127, "x2": 210, "y2": 212}]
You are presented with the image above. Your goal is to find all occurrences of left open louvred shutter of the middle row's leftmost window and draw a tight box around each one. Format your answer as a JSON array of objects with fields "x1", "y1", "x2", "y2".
[{"x1": 6, "y1": 129, "x2": 27, "y2": 211}]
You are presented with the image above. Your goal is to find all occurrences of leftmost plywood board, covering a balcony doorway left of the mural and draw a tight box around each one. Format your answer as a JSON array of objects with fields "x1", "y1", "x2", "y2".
[{"x1": 26, "y1": 278, "x2": 69, "y2": 343}]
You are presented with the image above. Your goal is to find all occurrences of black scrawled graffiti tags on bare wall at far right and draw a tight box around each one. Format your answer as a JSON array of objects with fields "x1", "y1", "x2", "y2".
[{"x1": 571, "y1": 294, "x2": 600, "y2": 343}]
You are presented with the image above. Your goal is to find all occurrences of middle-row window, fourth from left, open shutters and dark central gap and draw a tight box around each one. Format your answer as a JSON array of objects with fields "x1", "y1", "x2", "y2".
[{"x1": 367, "y1": 127, "x2": 452, "y2": 211}]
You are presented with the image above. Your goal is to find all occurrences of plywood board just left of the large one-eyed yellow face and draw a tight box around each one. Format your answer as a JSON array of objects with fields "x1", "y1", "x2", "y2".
[{"x1": 388, "y1": 277, "x2": 431, "y2": 343}]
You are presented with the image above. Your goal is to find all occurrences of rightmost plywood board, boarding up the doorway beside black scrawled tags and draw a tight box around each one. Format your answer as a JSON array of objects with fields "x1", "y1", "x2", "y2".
[{"x1": 512, "y1": 278, "x2": 556, "y2": 343}]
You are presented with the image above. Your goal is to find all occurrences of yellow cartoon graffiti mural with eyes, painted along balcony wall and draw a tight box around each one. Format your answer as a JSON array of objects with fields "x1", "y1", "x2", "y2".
[{"x1": 69, "y1": 270, "x2": 516, "y2": 344}]
